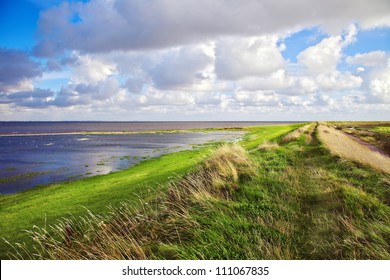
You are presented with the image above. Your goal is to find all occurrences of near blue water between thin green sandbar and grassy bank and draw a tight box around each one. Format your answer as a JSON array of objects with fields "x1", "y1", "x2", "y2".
[{"x1": 0, "y1": 130, "x2": 241, "y2": 194}]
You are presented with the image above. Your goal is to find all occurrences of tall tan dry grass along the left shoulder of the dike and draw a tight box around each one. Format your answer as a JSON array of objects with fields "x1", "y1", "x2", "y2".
[{"x1": 16, "y1": 144, "x2": 255, "y2": 260}]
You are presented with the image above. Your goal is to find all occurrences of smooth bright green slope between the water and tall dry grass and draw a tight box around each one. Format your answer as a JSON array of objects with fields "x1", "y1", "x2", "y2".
[{"x1": 0, "y1": 148, "x2": 210, "y2": 259}]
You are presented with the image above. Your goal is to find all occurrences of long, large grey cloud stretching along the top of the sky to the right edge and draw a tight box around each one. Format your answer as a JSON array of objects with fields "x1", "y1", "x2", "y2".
[{"x1": 35, "y1": 0, "x2": 390, "y2": 56}]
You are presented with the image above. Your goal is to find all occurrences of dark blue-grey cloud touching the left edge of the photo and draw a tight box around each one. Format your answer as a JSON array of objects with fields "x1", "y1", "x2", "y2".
[{"x1": 0, "y1": 48, "x2": 42, "y2": 92}]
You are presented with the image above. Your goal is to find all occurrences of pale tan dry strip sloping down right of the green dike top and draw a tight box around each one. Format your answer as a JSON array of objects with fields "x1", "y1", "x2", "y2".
[{"x1": 318, "y1": 125, "x2": 390, "y2": 173}]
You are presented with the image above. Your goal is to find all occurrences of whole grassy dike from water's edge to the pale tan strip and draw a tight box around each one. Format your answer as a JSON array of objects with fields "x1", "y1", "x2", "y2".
[{"x1": 0, "y1": 125, "x2": 389, "y2": 260}]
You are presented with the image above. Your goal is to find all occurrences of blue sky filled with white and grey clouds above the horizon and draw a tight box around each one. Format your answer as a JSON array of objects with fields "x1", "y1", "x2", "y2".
[{"x1": 0, "y1": 0, "x2": 390, "y2": 121}]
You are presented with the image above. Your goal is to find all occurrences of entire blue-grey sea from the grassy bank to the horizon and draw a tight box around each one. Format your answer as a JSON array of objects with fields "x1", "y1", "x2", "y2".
[{"x1": 0, "y1": 122, "x2": 300, "y2": 194}]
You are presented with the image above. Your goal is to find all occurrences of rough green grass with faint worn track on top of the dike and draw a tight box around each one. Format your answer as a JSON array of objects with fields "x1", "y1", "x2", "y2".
[{"x1": 174, "y1": 126, "x2": 390, "y2": 259}]
